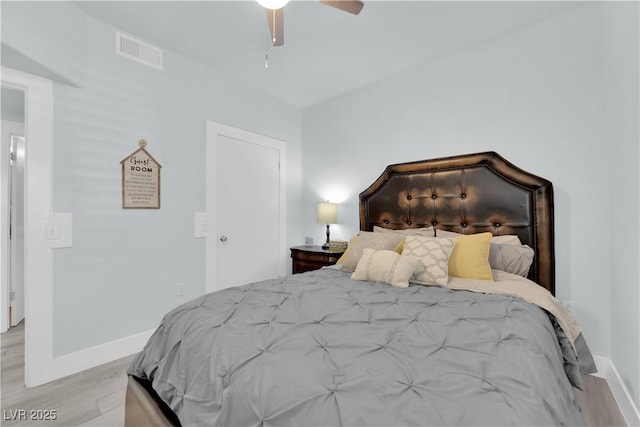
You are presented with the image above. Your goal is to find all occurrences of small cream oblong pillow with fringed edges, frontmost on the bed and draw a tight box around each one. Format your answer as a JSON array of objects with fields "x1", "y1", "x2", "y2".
[{"x1": 351, "y1": 248, "x2": 420, "y2": 288}]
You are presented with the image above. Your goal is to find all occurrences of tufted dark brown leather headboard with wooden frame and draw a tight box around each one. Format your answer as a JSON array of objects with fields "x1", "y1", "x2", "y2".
[{"x1": 360, "y1": 152, "x2": 555, "y2": 294}]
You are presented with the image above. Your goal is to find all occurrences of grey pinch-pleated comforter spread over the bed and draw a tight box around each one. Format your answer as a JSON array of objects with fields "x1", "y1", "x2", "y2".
[{"x1": 129, "y1": 269, "x2": 582, "y2": 426}]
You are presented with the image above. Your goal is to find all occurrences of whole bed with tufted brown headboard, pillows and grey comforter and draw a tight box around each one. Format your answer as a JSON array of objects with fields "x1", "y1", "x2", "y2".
[{"x1": 125, "y1": 152, "x2": 595, "y2": 426}]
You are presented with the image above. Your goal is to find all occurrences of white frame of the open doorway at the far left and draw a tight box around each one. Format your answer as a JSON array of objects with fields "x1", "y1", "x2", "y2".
[{"x1": 1, "y1": 67, "x2": 55, "y2": 387}]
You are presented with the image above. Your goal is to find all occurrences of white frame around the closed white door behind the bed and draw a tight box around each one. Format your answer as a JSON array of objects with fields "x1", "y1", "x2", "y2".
[{"x1": 205, "y1": 120, "x2": 287, "y2": 293}]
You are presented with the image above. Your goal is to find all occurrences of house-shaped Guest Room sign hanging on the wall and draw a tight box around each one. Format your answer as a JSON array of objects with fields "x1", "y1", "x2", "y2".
[{"x1": 120, "y1": 139, "x2": 162, "y2": 209}]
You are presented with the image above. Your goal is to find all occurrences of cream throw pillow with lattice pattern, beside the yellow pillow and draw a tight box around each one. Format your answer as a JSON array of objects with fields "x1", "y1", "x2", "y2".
[{"x1": 402, "y1": 236, "x2": 455, "y2": 286}]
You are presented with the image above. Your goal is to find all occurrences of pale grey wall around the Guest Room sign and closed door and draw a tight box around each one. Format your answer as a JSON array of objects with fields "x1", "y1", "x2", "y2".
[{"x1": 2, "y1": 2, "x2": 301, "y2": 356}]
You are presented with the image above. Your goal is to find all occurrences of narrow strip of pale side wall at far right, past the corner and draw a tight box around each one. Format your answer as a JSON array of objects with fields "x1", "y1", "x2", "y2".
[{"x1": 604, "y1": 2, "x2": 640, "y2": 408}]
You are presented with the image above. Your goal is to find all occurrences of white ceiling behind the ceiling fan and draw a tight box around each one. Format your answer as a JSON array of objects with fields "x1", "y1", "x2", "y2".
[{"x1": 77, "y1": 0, "x2": 581, "y2": 108}]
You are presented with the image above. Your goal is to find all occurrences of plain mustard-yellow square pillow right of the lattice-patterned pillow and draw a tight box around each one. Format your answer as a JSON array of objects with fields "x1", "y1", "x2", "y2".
[{"x1": 449, "y1": 233, "x2": 493, "y2": 282}]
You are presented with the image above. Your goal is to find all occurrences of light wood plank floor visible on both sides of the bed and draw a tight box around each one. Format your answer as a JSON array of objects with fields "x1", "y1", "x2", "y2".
[{"x1": 0, "y1": 324, "x2": 626, "y2": 427}]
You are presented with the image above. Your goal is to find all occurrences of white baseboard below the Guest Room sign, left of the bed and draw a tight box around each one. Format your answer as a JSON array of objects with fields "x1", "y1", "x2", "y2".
[{"x1": 44, "y1": 329, "x2": 154, "y2": 382}]
